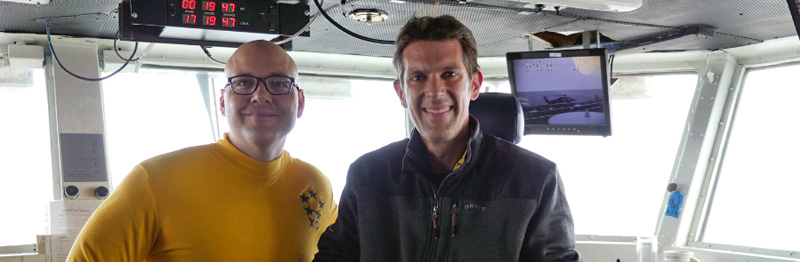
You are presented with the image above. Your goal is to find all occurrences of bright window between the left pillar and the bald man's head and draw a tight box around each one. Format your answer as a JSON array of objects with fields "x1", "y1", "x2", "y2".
[{"x1": 103, "y1": 68, "x2": 215, "y2": 188}]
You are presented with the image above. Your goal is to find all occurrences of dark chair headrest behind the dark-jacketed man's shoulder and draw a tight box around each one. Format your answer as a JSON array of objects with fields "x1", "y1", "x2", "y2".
[{"x1": 469, "y1": 93, "x2": 525, "y2": 144}]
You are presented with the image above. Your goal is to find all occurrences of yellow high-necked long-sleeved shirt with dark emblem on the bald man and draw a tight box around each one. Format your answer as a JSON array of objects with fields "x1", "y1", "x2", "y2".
[{"x1": 67, "y1": 135, "x2": 337, "y2": 262}]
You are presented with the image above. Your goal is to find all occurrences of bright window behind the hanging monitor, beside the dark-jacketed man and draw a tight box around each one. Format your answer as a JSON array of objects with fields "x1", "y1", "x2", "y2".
[{"x1": 520, "y1": 73, "x2": 697, "y2": 236}]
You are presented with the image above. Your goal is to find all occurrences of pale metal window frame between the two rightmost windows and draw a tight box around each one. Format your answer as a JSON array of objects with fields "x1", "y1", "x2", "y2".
[{"x1": 576, "y1": 49, "x2": 800, "y2": 262}]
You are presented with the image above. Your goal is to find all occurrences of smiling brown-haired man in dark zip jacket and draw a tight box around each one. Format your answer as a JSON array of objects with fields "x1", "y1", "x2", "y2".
[{"x1": 314, "y1": 16, "x2": 582, "y2": 262}]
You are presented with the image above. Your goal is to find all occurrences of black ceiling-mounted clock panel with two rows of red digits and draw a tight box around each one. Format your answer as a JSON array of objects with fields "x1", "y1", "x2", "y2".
[{"x1": 136, "y1": 0, "x2": 310, "y2": 43}]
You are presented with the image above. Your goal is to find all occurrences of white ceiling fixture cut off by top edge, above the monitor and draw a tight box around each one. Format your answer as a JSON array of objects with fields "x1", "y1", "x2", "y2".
[{"x1": 519, "y1": 0, "x2": 643, "y2": 12}]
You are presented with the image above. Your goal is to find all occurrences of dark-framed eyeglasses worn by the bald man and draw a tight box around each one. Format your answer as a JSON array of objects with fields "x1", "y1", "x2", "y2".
[{"x1": 228, "y1": 75, "x2": 300, "y2": 95}]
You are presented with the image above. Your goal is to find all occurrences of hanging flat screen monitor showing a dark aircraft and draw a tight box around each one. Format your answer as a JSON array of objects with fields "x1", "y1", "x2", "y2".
[{"x1": 506, "y1": 48, "x2": 611, "y2": 136}]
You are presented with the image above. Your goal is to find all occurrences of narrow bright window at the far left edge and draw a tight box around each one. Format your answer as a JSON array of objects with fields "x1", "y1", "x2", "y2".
[{"x1": 0, "y1": 67, "x2": 53, "y2": 246}]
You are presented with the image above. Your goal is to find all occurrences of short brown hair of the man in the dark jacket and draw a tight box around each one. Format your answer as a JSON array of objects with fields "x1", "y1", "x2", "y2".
[{"x1": 393, "y1": 15, "x2": 480, "y2": 82}]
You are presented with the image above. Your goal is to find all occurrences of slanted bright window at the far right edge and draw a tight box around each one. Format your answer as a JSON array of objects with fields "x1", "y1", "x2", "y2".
[{"x1": 701, "y1": 64, "x2": 800, "y2": 254}]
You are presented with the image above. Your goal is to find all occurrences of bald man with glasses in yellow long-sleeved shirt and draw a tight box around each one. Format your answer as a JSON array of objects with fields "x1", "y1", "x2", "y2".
[{"x1": 67, "y1": 41, "x2": 337, "y2": 262}]
